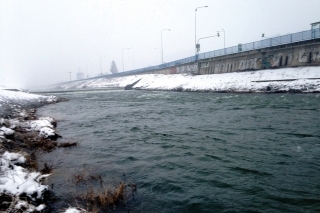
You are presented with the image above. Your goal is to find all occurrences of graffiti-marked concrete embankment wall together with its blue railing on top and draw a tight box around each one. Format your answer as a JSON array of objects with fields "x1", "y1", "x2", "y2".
[{"x1": 63, "y1": 27, "x2": 320, "y2": 84}]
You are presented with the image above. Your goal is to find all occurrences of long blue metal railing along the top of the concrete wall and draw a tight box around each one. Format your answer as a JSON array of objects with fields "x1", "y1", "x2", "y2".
[{"x1": 90, "y1": 29, "x2": 320, "y2": 78}]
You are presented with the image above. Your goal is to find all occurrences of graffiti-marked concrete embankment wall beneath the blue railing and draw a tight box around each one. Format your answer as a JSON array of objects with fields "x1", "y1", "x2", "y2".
[{"x1": 141, "y1": 39, "x2": 320, "y2": 74}]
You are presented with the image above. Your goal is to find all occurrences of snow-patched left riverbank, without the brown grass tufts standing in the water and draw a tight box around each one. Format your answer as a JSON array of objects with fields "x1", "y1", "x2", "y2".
[{"x1": 0, "y1": 89, "x2": 64, "y2": 212}]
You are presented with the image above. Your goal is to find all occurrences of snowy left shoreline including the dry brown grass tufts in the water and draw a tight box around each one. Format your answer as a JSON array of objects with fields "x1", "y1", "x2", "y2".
[{"x1": 0, "y1": 90, "x2": 136, "y2": 213}]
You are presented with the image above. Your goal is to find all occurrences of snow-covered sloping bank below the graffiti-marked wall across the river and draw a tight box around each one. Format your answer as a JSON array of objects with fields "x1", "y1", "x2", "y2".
[{"x1": 59, "y1": 67, "x2": 320, "y2": 92}]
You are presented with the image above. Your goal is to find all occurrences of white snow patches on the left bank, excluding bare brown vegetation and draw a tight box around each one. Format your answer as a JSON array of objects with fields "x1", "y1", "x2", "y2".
[{"x1": 0, "y1": 88, "x2": 57, "y2": 212}]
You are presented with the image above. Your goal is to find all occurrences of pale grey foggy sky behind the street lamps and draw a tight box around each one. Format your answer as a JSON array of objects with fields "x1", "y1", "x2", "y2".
[{"x1": 0, "y1": 0, "x2": 320, "y2": 88}]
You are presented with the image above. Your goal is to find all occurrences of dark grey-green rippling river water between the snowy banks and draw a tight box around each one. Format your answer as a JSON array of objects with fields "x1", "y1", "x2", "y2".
[{"x1": 38, "y1": 90, "x2": 320, "y2": 213}]
